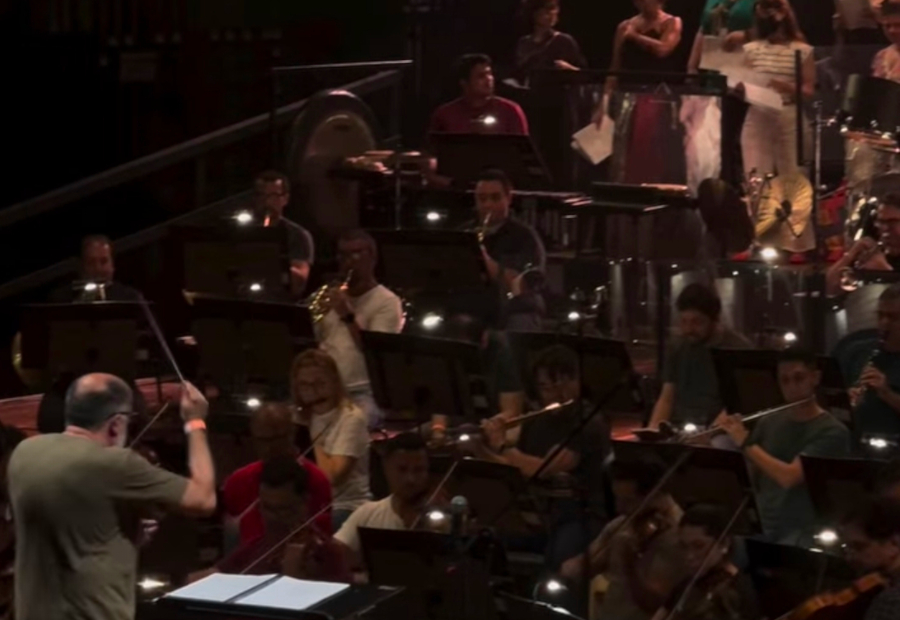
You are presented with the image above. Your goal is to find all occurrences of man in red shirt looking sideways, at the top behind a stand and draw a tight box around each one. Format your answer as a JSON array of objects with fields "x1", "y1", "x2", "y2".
[{"x1": 428, "y1": 54, "x2": 528, "y2": 135}]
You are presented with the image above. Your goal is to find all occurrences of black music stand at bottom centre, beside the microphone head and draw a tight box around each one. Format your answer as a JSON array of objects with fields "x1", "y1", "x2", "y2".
[{"x1": 359, "y1": 527, "x2": 497, "y2": 620}]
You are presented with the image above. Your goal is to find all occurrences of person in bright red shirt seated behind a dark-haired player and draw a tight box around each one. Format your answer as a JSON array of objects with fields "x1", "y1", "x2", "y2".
[{"x1": 222, "y1": 403, "x2": 332, "y2": 544}]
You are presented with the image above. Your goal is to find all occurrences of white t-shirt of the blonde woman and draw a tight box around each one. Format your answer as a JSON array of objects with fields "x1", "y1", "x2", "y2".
[{"x1": 309, "y1": 402, "x2": 372, "y2": 510}]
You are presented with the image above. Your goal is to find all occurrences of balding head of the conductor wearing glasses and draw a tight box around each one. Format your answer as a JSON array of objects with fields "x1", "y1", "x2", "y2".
[{"x1": 66, "y1": 373, "x2": 133, "y2": 445}]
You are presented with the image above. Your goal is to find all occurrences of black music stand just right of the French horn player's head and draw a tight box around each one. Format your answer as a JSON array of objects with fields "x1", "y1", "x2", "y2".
[{"x1": 372, "y1": 230, "x2": 489, "y2": 295}]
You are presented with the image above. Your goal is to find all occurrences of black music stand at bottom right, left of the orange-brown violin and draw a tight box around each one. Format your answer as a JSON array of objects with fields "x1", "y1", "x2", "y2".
[{"x1": 744, "y1": 538, "x2": 857, "y2": 618}]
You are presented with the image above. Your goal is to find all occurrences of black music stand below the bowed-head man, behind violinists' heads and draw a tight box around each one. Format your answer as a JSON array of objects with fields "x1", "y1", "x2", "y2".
[{"x1": 613, "y1": 441, "x2": 762, "y2": 536}]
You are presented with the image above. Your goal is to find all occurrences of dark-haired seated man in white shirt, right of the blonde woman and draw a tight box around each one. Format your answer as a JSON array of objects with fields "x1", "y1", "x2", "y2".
[{"x1": 334, "y1": 433, "x2": 429, "y2": 570}]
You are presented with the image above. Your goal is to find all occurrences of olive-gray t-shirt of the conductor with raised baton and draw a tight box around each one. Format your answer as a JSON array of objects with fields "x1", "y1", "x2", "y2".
[{"x1": 8, "y1": 434, "x2": 187, "y2": 620}]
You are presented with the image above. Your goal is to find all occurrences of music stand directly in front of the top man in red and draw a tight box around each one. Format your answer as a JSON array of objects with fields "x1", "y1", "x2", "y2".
[{"x1": 428, "y1": 133, "x2": 553, "y2": 190}]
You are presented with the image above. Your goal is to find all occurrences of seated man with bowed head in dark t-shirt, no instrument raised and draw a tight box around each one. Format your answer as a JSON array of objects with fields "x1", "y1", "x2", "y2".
[{"x1": 650, "y1": 284, "x2": 751, "y2": 428}]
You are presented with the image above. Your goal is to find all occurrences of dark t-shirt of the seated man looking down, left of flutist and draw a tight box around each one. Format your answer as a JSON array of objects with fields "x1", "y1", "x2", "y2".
[{"x1": 663, "y1": 329, "x2": 752, "y2": 426}]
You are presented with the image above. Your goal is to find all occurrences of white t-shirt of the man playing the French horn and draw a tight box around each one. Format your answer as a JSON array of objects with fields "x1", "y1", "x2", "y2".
[{"x1": 316, "y1": 284, "x2": 403, "y2": 389}]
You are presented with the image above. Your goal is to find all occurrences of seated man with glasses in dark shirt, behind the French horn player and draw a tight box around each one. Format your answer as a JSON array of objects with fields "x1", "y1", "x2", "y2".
[{"x1": 253, "y1": 170, "x2": 316, "y2": 297}]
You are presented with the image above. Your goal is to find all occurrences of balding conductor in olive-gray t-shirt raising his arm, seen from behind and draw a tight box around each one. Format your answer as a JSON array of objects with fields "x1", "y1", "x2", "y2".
[{"x1": 8, "y1": 374, "x2": 216, "y2": 620}]
